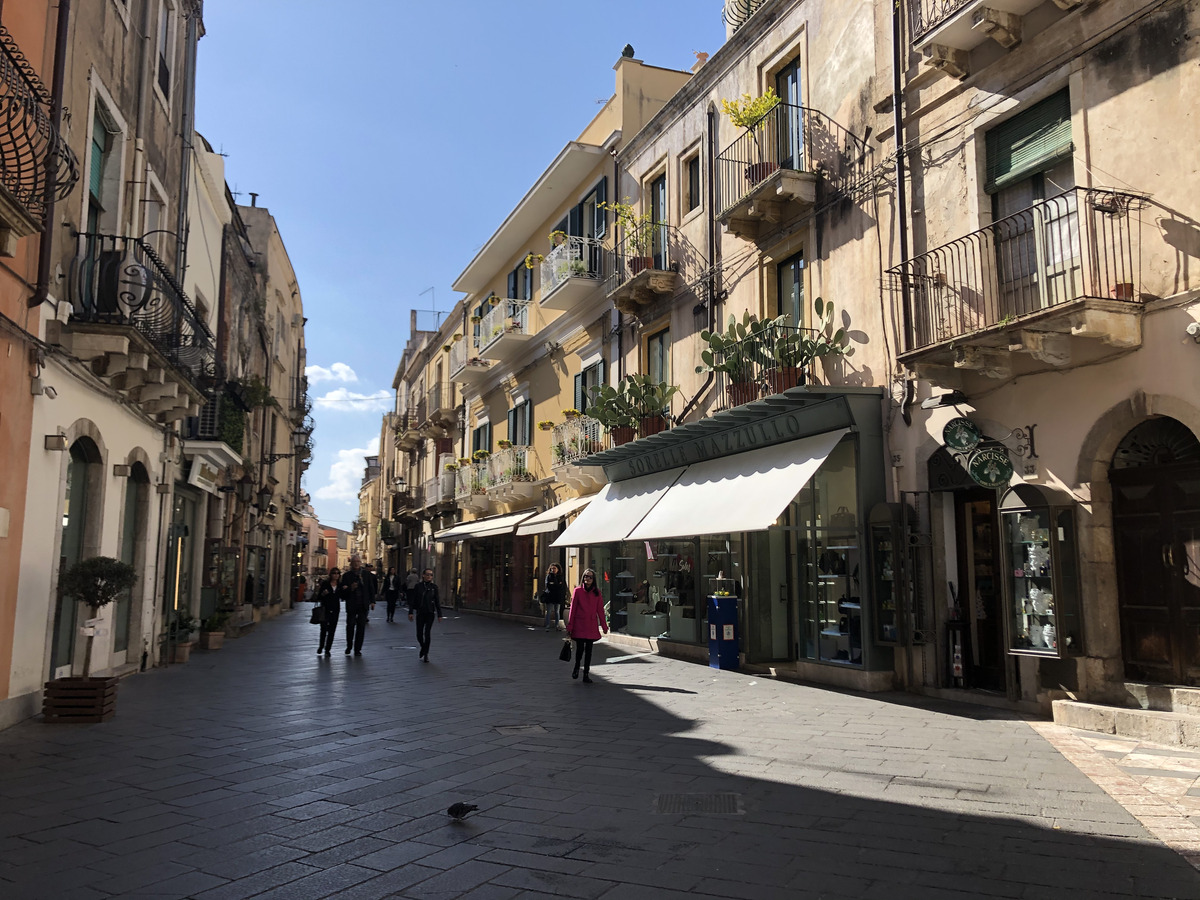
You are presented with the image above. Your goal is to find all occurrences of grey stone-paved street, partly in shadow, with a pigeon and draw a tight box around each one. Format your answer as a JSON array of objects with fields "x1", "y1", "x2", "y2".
[{"x1": 0, "y1": 611, "x2": 1200, "y2": 900}]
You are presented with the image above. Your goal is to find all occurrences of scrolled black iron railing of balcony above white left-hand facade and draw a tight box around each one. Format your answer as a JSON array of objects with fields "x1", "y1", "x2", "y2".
[{"x1": 70, "y1": 234, "x2": 216, "y2": 384}]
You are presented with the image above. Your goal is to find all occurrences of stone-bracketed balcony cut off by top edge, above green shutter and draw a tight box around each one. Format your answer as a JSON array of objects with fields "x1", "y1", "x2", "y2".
[{"x1": 908, "y1": 0, "x2": 1060, "y2": 63}]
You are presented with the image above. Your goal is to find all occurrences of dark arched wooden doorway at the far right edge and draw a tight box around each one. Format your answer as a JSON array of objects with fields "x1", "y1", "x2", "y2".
[{"x1": 1109, "y1": 416, "x2": 1200, "y2": 685}]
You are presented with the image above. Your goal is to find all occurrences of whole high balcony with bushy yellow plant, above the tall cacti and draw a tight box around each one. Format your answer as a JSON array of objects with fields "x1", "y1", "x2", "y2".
[{"x1": 716, "y1": 103, "x2": 871, "y2": 241}]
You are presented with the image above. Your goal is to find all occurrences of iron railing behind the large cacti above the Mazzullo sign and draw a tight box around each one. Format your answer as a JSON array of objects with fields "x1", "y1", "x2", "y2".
[{"x1": 713, "y1": 324, "x2": 818, "y2": 410}]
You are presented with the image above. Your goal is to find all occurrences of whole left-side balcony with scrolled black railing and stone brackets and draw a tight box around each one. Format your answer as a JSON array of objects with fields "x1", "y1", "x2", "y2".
[{"x1": 47, "y1": 234, "x2": 216, "y2": 422}]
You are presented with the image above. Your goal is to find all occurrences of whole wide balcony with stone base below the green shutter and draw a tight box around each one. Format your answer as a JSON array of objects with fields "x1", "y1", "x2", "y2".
[{"x1": 888, "y1": 188, "x2": 1146, "y2": 386}]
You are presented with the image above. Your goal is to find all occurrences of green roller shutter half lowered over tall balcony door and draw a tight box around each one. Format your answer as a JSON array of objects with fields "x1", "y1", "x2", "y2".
[{"x1": 984, "y1": 91, "x2": 1074, "y2": 193}]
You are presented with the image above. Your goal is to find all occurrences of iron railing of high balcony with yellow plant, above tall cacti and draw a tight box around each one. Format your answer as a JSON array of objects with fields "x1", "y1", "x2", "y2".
[{"x1": 716, "y1": 103, "x2": 871, "y2": 218}]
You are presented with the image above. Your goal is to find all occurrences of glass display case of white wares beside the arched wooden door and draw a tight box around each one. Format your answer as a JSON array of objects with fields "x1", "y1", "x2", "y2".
[{"x1": 1000, "y1": 485, "x2": 1082, "y2": 658}]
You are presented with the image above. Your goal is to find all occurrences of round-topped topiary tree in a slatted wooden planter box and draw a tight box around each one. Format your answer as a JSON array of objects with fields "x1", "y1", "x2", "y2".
[{"x1": 42, "y1": 557, "x2": 138, "y2": 722}]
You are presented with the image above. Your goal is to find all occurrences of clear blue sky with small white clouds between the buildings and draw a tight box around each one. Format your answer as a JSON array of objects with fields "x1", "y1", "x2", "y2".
[{"x1": 196, "y1": 0, "x2": 725, "y2": 528}]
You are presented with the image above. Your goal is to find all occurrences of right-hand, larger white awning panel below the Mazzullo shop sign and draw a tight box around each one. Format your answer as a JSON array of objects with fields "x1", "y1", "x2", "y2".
[{"x1": 618, "y1": 428, "x2": 850, "y2": 540}]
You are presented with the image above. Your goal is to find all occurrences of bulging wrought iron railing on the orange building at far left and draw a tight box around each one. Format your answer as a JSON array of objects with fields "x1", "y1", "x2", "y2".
[{"x1": 0, "y1": 25, "x2": 79, "y2": 224}]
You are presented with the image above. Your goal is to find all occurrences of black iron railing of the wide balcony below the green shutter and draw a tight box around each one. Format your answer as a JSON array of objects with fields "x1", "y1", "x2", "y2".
[{"x1": 888, "y1": 187, "x2": 1146, "y2": 350}]
